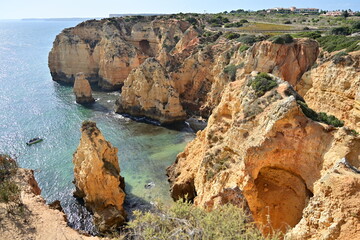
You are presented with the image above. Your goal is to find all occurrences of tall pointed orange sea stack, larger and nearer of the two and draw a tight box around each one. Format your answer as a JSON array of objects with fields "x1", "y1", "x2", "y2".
[{"x1": 73, "y1": 121, "x2": 126, "y2": 232}]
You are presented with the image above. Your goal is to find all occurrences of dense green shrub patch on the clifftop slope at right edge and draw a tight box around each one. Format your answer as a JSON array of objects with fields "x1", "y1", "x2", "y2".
[{"x1": 316, "y1": 35, "x2": 360, "y2": 52}]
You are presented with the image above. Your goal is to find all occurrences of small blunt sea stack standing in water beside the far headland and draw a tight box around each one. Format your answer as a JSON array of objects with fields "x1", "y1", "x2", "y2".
[{"x1": 73, "y1": 73, "x2": 95, "y2": 104}]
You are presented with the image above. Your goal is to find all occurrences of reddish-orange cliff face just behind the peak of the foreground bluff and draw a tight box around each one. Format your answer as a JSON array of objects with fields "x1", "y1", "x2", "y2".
[{"x1": 244, "y1": 39, "x2": 319, "y2": 86}]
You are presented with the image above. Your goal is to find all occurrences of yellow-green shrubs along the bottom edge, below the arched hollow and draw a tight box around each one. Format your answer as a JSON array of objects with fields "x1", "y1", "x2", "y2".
[{"x1": 128, "y1": 201, "x2": 280, "y2": 240}]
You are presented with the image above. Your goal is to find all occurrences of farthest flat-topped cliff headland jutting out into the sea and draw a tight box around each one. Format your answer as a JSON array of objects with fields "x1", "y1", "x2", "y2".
[{"x1": 49, "y1": 17, "x2": 196, "y2": 90}]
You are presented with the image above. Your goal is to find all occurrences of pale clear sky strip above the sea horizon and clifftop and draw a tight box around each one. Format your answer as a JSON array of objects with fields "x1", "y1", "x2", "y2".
[{"x1": 0, "y1": 0, "x2": 360, "y2": 19}]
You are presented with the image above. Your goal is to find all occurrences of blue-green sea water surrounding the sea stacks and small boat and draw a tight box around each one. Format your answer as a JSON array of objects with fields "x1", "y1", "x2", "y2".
[{"x1": 0, "y1": 20, "x2": 194, "y2": 232}]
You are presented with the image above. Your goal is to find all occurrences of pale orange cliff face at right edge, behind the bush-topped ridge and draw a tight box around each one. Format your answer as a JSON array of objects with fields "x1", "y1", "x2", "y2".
[{"x1": 296, "y1": 51, "x2": 360, "y2": 132}]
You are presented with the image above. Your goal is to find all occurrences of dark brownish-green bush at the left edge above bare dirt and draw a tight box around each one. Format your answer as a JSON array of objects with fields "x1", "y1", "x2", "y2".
[{"x1": 0, "y1": 154, "x2": 20, "y2": 203}]
